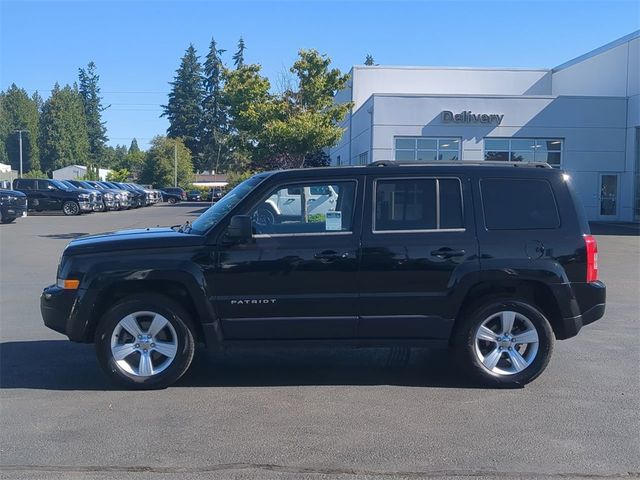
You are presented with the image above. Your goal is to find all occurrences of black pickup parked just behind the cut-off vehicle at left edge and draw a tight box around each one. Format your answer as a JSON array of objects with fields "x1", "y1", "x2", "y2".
[{"x1": 13, "y1": 178, "x2": 97, "y2": 215}]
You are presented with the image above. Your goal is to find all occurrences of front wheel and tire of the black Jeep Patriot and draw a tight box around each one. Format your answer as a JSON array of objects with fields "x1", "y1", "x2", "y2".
[{"x1": 94, "y1": 294, "x2": 195, "y2": 390}]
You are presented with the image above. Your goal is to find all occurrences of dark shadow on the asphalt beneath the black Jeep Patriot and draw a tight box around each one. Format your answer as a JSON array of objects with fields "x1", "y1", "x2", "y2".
[{"x1": 0, "y1": 340, "x2": 490, "y2": 390}]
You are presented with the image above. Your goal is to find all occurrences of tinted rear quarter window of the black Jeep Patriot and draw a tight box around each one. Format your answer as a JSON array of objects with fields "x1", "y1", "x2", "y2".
[{"x1": 480, "y1": 178, "x2": 560, "y2": 230}]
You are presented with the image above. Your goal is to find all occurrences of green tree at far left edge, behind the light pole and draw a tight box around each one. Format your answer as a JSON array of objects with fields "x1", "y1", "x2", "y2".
[{"x1": 0, "y1": 83, "x2": 40, "y2": 172}]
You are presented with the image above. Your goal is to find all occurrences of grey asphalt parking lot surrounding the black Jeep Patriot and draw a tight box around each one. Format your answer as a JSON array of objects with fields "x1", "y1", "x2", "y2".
[{"x1": 0, "y1": 203, "x2": 640, "y2": 479}]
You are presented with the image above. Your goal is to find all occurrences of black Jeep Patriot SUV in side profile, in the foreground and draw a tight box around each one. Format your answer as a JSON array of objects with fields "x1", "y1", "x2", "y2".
[{"x1": 41, "y1": 162, "x2": 606, "y2": 388}]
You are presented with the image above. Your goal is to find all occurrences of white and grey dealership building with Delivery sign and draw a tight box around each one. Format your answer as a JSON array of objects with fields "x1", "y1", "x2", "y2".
[{"x1": 329, "y1": 31, "x2": 640, "y2": 221}]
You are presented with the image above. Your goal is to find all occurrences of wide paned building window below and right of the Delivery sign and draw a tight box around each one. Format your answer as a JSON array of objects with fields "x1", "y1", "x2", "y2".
[{"x1": 484, "y1": 138, "x2": 564, "y2": 168}]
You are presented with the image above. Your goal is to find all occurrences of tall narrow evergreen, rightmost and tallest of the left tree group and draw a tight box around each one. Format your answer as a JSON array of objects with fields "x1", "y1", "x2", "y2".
[{"x1": 78, "y1": 62, "x2": 108, "y2": 165}]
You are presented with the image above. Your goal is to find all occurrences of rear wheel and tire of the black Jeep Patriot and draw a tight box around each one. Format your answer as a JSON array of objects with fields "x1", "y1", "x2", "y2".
[{"x1": 452, "y1": 299, "x2": 555, "y2": 387}]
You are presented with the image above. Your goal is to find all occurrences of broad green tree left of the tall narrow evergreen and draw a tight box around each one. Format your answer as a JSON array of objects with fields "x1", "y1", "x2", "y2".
[{"x1": 40, "y1": 83, "x2": 89, "y2": 172}]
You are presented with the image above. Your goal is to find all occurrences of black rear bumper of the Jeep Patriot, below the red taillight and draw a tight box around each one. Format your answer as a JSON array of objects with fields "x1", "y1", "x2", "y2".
[{"x1": 554, "y1": 282, "x2": 607, "y2": 340}]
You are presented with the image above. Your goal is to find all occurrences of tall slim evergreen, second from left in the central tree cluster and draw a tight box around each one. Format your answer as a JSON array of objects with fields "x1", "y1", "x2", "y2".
[{"x1": 204, "y1": 38, "x2": 228, "y2": 171}]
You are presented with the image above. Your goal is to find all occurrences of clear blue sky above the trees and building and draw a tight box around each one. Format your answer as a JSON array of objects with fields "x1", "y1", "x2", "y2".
[{"x1": 0, "y1": 0, "x2": 640, "y2": 148}]
